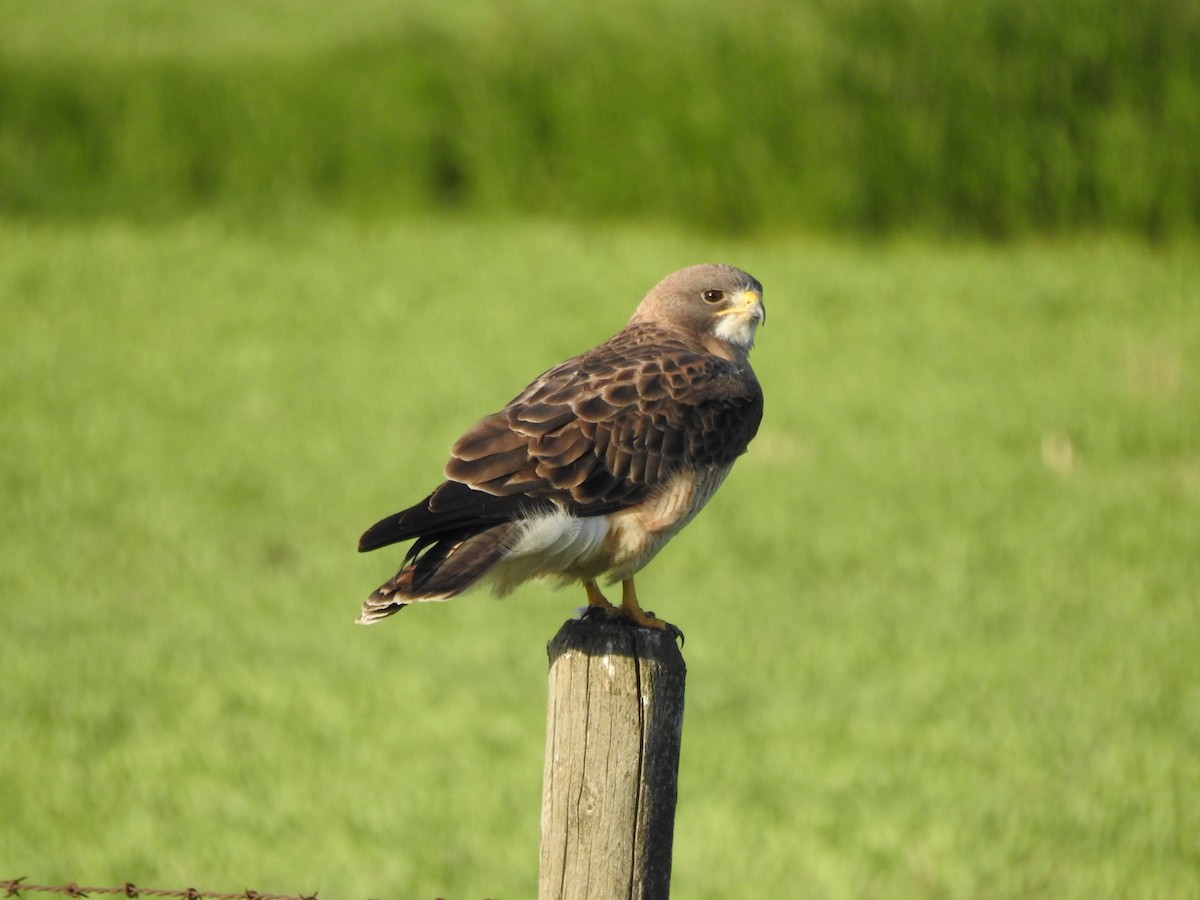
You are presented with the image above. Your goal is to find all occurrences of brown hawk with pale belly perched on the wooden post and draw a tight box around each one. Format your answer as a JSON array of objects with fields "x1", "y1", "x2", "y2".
[{"x1": 358, "y1": 264, "x2": 766, "y2": 634}]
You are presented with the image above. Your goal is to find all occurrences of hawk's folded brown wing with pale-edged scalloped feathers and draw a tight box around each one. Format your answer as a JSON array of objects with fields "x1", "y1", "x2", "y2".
[{"x1": 445, "y1": 324, "x2": 762, "y2": 515}]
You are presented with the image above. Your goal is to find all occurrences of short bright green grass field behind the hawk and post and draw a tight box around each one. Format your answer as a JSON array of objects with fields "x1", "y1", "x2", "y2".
[{"x1": 0, "y1": 218, "x2": 1200, "y2": 900}]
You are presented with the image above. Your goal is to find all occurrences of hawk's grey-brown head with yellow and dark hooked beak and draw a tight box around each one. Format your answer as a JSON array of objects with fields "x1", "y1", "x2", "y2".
[{"x1": 630, "y1": 263, "x2": 767, "y2": 350}]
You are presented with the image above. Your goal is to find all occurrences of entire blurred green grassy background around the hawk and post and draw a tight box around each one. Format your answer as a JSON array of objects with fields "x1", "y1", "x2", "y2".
[{"x1": 0, "y1": 0, "x2": 1200, "y2": 900}]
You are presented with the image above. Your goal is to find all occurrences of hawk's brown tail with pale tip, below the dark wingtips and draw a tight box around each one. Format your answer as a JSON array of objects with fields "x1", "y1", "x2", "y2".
[{"x1": 358, "y1": 522, "x2": 520, "y2": 625}]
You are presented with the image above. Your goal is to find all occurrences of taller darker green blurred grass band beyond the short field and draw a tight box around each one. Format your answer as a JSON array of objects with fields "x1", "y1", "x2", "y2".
[{"x1": 0, "y1": 0, "x2": 1200, "y2": 236}]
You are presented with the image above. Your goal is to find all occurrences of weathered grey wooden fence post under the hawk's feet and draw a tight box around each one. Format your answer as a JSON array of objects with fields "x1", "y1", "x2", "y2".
[{"x1": 538, "y1": 618, "x2": 686, "y2": 900}]
